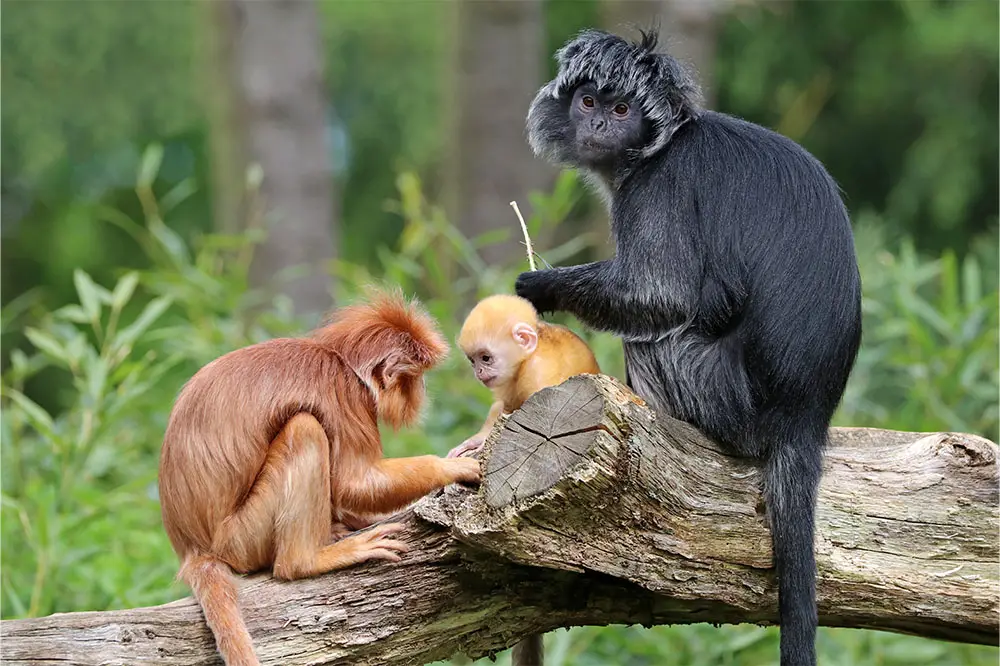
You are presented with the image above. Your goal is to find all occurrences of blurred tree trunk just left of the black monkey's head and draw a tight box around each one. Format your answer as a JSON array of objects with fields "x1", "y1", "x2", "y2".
[{"x1": 449, "y1": 0, "x2": 554, "y2": 270}]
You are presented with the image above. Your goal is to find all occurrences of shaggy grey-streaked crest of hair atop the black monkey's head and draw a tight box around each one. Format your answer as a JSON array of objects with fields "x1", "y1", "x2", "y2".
[{"x1": 529, "y1": 29, "x2": 701, "y2": 158}]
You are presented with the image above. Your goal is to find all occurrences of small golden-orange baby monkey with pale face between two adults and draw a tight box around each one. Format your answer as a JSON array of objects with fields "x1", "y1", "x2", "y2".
[{"x1": 448, "y1": 294, "x2": 601, "y2": 458}]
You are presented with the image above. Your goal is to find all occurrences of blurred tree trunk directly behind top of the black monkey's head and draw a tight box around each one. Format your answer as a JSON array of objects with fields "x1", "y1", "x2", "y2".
[{"x1": 603, "y1": 0, "x2": 727, "y2": 107}]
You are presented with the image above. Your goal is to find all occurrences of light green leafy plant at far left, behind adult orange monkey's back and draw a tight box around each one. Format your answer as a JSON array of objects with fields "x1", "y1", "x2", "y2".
[{"x1": 0, "y1": 271, "x2": 177, "y2": 617}]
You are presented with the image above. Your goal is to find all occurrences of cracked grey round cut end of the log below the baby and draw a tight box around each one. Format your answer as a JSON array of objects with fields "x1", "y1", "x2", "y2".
[{"x1": 483, "y1": 375, "x2": 604, "y2": 508}]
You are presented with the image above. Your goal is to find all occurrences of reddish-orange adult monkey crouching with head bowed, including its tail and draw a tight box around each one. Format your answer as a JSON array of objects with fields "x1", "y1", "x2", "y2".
[{"x1": 160, "y1": 293, "x2": 480, "y2": 666}]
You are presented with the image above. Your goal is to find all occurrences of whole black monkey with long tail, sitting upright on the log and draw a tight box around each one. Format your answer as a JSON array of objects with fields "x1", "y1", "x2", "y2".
[{"x1": 515, "y1": 30, "x2": 861, "y2": 666}]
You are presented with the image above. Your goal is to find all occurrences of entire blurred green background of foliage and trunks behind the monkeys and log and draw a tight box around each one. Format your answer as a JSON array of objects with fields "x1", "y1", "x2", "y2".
[{"x1": 0, "y1": 0, "x2": 1000, "y2": 666}]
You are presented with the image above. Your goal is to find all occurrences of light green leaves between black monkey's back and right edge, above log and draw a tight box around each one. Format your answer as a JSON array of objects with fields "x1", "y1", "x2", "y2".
[{"x1": 837, "y1": 219, "x2": 1000, "y2": 441}]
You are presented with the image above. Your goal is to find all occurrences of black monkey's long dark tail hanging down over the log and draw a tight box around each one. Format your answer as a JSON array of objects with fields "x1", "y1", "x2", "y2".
[{"x1": 764, "y1": 429, "x2": 826, "y2": 666}]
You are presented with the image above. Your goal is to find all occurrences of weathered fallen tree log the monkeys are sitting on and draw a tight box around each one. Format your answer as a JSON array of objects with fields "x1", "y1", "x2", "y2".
[{"x1": 0, "y1": 377, "x2": 1000, "y2": 666}]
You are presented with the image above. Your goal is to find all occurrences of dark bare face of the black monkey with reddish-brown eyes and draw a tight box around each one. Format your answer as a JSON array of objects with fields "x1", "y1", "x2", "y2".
[{"x1": 569, "y1": 83, "x2": 649, "y2": 169}]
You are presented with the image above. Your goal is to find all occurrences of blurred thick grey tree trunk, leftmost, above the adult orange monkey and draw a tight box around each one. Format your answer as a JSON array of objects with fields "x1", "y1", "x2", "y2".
[{"x1": 205, "y1": 0, "x2": 338, "y2": 315}]
